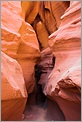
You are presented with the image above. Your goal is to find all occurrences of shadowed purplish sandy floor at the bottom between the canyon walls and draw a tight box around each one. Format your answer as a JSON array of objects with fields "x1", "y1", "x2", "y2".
[{"x1": 23, "y1": 96, "x2": 65, "y2": 121}]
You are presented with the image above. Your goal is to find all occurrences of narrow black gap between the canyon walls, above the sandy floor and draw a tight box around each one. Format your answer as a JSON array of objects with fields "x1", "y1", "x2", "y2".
[{"x1": 27, "y1": 64, "x2": 46, "y2": 106}]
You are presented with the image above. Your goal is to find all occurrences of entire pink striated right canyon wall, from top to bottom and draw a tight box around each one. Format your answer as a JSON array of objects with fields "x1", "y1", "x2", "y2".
[{"x1": 44, "y1": 1, "x2": 81, "y2": 121}]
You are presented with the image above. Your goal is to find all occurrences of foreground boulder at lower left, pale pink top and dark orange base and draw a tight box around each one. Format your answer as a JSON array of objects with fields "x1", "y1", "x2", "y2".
[{"x1": 1, "y1": 52, "x2": 27, "y2": 121}]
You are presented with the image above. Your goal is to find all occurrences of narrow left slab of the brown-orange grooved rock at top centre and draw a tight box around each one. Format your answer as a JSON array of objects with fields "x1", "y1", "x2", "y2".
[{"x1": 39, "y1": 1, "x2": 57, "y2": 34}]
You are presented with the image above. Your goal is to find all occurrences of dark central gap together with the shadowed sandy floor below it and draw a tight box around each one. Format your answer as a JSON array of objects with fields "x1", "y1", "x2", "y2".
[{"x1": 24, "y1": 62, "x2": 65, "y2": 121}]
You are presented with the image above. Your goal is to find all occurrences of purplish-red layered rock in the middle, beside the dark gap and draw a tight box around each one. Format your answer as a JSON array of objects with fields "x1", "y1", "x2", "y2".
[{"x1": 38, "y1": 47, "x2": 54, "y2": 88}]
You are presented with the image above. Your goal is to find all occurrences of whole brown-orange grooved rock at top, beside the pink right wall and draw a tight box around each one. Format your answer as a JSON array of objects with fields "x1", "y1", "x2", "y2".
[{"x1": 39, "y1": 1, "x2": 69, "y2": 34}]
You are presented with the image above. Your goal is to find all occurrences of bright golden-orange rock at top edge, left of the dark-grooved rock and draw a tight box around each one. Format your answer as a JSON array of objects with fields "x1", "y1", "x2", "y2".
[{"x1": 22, "y1": 1, "x2": 40, "y2": 24}]
